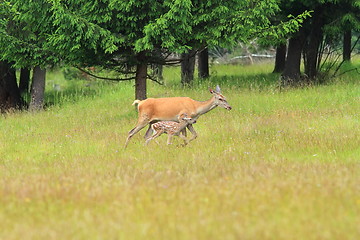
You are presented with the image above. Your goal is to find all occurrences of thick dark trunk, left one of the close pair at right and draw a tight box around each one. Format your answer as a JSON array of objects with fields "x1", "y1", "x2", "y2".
[{"x1": 281, "y1": 30, "x2": 305, "y2": 86}]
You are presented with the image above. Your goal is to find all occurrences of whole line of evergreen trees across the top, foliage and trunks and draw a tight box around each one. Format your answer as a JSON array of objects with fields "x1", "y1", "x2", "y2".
[{"x1": 0, "y1": 0, "x2": 360, "y2": 111}]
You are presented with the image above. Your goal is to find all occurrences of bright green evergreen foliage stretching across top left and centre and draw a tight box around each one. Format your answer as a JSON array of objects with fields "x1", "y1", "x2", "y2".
[{"x1": 0, "y1": 0, "x2": 306, "y2": 73}]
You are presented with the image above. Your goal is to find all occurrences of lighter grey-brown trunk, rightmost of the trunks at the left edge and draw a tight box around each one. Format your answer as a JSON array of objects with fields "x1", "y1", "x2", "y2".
[{"x1": 29, "y1": 66, "x2": 46, "y2": 111}]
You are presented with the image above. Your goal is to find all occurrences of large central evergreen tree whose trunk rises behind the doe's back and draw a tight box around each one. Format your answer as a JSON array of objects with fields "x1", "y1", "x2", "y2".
[{"x1": 50, "y1": 0, "x2": 300, "y2": 99}]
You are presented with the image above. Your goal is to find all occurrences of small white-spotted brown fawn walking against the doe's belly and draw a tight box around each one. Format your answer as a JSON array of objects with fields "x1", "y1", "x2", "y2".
[{"x1": 145, "y1": 114, "x2": 196, "y2": 145}]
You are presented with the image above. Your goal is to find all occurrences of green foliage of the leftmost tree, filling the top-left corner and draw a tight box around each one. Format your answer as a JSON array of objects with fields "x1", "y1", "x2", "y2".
[{"x1": 0, "y1": 0, "x2": 60, "y2": 67}]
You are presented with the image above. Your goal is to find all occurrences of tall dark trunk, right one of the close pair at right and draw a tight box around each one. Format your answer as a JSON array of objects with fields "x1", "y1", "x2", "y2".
[{"x1": 304, "y1": 8, "x2": 324, "y2": 80}]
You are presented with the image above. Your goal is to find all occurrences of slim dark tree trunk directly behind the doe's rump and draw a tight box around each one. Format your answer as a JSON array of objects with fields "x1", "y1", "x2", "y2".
[{"x1": 135, "y1": 52, "x2": 147, "y2": 100}]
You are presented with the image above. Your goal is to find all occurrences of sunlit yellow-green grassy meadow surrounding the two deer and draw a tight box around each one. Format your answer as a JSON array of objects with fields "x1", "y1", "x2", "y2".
[{"x1": 0, "y1": 64, "x2": 360, "y2": 240}]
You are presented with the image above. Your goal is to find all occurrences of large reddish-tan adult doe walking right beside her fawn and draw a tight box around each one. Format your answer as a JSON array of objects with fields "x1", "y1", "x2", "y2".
[{"x1": 125, "y1": 86, "x2": 231, "y2": 147}]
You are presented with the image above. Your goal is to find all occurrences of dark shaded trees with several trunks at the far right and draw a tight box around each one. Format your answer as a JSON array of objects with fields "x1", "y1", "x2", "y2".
[{"x1": 274, "y1": 0, "x2": 360, "y2": 86}]
